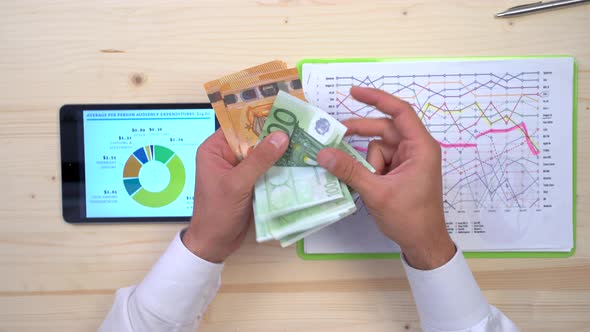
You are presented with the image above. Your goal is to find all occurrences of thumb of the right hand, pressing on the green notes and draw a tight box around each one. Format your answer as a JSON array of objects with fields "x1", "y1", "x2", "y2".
[{"x1": 317, "y1": 148, "x2": 376, "y2": 196}]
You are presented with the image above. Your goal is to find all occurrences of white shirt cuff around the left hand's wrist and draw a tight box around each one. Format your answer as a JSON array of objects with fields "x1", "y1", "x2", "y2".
[{"x1": 135, "y1": 230, "x2": 223, "y2": 324}]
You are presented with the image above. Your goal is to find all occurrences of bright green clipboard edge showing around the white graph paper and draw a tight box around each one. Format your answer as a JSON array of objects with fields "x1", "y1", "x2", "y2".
[{"x1": 297, "y1": 55, "x2": 578, "y2": 260}]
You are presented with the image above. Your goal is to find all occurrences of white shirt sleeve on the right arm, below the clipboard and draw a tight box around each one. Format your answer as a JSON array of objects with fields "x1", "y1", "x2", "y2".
[{"x1": 402, "y1": 249, "x2": 519, "y2": 332}]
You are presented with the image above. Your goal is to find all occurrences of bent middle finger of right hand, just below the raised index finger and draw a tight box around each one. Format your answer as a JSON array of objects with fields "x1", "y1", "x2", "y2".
[{"x1": 342, "y1": 118, "x2": 401, "y2": 144}]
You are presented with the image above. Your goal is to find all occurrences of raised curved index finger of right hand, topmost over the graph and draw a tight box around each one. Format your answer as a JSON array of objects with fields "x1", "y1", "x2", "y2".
[{"x1": 350, "y1": 87, "x2": 428, "y2": 138}]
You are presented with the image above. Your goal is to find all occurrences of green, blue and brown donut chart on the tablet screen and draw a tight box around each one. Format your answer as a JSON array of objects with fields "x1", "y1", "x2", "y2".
[{"x1": 123, "y1": 145, "x2": 186, "y2": 208}]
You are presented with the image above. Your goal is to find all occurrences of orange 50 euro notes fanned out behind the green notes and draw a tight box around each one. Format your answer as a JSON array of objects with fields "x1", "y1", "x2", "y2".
[{"x1": 205, "y1": 61, "x2": 305, "y2": 159}]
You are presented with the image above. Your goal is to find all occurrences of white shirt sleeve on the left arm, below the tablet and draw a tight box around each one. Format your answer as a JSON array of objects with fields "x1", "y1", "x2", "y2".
[{"x1": 99, "y1": 232, "x2": 223, "y2": 332}]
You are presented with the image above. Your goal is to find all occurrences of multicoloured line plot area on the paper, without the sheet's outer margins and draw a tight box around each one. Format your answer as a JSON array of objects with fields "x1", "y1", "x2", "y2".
[{"x1": 308, "y1": 71, "x2": 549, "y2": 211}]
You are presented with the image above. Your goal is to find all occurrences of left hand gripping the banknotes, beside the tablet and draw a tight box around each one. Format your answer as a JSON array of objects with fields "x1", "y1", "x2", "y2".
[{"x1": 182, "y1": 130, "x2": 289, "y2": 263}]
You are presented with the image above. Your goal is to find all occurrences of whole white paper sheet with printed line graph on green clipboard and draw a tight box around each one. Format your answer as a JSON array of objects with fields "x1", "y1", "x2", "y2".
[{"x1": 301, "y1": 58, "x2": 574, "y2": 252}]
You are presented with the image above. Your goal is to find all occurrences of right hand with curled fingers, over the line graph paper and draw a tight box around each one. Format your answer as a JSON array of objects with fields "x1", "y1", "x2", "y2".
[{"x1": 318, "y1": 87, "x2": 456, "y2": 270}]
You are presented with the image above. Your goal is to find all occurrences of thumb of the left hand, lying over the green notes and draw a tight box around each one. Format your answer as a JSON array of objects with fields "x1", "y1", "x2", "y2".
[{"x1": 235, "y1": 131, "x2": 289, "y2": 188}]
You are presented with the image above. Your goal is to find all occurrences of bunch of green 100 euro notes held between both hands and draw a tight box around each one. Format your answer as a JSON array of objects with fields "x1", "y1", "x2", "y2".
[{"x1": 254, "y1": 92, "x2": 375, "y2": 246}]
